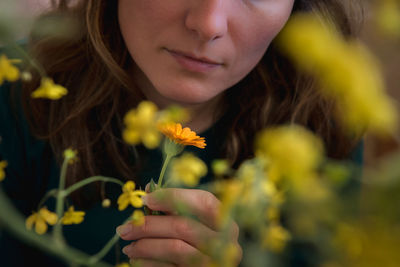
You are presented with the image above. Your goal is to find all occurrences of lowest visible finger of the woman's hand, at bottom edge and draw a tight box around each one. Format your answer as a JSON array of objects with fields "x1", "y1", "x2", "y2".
[{"x1": 122, "y1": 238, "x2": 210, "y2": 266}]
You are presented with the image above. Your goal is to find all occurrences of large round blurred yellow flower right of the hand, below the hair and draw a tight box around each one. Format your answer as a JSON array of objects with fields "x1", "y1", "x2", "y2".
[{"x1": 255, "y1": 125, "x2": 323, "y2": 182}]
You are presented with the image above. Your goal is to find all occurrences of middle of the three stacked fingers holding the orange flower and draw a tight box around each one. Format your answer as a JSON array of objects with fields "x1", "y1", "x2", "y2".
[{"x1": 117, "y1": 215, "x2": 219, "y2": 249}]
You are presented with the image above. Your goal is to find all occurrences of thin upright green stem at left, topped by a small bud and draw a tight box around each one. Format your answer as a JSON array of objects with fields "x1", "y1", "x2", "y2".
[{"x1": 53, "y1": 158, "x2": 69, "y2": 246}]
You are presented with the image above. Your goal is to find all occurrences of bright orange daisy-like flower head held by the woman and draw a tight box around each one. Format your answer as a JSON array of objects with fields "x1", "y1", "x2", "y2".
[{"x1": 159, "y1": 123, "x2": 206, "y2": 148}]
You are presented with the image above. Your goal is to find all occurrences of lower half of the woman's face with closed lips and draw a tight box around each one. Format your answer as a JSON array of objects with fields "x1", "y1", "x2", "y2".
[{"x1": 118, "y1": 0, "x2": 294, "y2": 107}]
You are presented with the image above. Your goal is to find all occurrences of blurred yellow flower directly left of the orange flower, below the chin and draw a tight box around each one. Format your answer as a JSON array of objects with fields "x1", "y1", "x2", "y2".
[{"x1": 122, "y1": 101, "x2": 161, "y2": 149}]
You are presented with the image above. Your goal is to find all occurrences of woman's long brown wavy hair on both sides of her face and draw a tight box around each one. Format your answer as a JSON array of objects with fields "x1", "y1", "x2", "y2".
[{"x1": 23, "y1": 0, "x2": 360, "y2": 203}]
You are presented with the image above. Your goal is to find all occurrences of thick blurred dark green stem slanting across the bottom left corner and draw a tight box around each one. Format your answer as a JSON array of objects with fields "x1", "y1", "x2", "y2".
[{"x1": 0, "y1": 188, "x2": 113, "y2": 267}]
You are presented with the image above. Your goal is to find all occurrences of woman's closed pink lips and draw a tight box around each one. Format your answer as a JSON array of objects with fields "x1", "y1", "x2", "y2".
[{"x1": 166, "y1": 49, "x2": 223, "y2": 72}]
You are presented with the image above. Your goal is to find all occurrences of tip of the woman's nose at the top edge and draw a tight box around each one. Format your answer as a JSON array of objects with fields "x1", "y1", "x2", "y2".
[{"x1": 185, "y1": 0, "x2": 228, "y2": 41}]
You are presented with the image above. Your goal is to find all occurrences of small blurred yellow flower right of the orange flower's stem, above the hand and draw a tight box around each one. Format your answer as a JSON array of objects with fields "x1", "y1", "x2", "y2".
[{"x1": 170, "y1": 153, "x2": 207, "y2": 187}]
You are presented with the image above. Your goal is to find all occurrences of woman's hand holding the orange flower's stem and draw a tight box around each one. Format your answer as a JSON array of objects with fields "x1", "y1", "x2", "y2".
[{"x1": 117, "y1": 188, "x2": 242, "y2": 267}]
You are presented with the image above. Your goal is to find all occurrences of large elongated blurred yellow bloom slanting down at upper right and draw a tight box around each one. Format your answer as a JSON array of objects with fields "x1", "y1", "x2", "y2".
[{"x1": 278, "y1": 14, "x2": 397, "y2": 134}]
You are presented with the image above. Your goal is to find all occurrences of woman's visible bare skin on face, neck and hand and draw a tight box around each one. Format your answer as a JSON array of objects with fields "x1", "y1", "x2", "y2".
[{"x1": 117, "y1": 0, "x2": 294, "y2": 266}]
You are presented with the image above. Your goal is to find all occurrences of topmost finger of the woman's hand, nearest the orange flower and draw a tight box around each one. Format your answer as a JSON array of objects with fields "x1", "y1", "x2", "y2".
[{"x1": 143, "y1": 188, "x2": 220, "y2": 230}]
